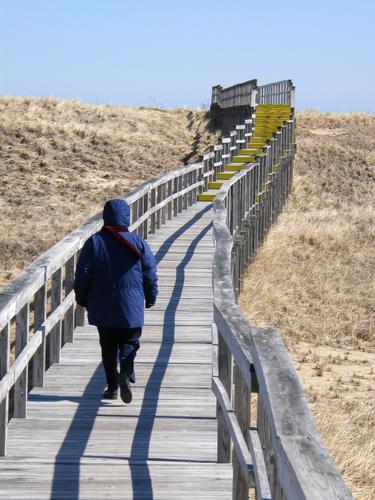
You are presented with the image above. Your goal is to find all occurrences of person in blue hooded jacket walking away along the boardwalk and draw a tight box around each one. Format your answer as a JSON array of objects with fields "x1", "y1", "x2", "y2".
[{"x1": 74, "y1": 199, "x2": 158, "y2": 403}]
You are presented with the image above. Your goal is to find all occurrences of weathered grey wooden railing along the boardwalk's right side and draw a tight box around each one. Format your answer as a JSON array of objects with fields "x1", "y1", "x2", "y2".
[{"x1": 212, "y1": 111, "x2": 352, "y2": 500}]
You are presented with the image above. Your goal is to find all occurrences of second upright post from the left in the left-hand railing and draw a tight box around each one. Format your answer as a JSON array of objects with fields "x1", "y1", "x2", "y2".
[{"x1": 13, "y1": 302, "x2": 30, "y2": 418}]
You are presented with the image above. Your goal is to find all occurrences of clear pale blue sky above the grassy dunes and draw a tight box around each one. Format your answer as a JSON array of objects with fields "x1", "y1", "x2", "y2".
[{"x1": 0, "y1": 0, "x2": 375, "y2": 112}]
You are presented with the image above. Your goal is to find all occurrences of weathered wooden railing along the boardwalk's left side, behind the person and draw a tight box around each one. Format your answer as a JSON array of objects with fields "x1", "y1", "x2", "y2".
[{"x1": 0, "y1": 162, "x2": 222, "y2": 455}]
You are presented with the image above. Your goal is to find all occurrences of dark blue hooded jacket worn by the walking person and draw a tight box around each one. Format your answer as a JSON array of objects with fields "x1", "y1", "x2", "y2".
[{"x1": 74, "y1": 199, "x2": 158, "y2": 328}]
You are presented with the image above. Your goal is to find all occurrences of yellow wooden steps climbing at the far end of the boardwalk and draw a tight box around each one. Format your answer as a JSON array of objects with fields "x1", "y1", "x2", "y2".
[{"x1": 198, "y1": 104, "x2": 292, "y2": 202}]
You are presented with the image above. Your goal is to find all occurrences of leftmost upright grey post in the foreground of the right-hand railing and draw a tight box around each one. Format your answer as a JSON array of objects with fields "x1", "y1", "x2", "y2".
[{"x1": 216, "y1": 332, "x2": 232, "y2": 463}]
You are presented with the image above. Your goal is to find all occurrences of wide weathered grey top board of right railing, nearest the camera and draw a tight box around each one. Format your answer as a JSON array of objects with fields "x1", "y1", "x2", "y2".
[{"x1": 249, "y1": 328, "x2": 352, "y2": 499}]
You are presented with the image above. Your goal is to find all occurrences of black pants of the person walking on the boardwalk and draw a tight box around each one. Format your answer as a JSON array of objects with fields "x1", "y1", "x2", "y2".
[{"x1": 98, "y1": 326, "x2": 142, "y2": 390}]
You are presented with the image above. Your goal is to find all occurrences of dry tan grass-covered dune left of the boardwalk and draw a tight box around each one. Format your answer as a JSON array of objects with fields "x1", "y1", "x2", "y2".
[{"x1": 0, "y1": 97, "x2": 219, "y2": 286}]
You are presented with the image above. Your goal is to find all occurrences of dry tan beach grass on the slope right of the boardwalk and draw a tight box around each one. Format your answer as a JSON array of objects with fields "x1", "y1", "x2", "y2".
[{"x1": 240, "y1": 111, "x2": 375, "y2": 500}]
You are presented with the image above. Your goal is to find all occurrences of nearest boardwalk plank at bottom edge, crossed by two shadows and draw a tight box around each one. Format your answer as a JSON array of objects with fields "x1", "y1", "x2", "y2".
[{"x1": 0, "y1": 461, "x2": 231, "y2": 500}]
